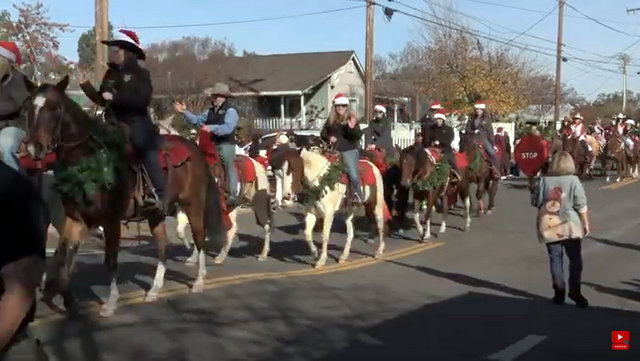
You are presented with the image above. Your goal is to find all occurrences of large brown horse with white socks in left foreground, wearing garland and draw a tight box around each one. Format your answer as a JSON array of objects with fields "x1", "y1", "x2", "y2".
[{"x1": 26, "y1": 77, "x2": 222, "y2": 317}]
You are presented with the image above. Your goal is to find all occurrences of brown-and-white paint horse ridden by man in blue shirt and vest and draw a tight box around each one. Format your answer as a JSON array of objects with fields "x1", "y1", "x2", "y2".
[{"x1": 178, "y1": 131, "x2": 272, "y2": 265}]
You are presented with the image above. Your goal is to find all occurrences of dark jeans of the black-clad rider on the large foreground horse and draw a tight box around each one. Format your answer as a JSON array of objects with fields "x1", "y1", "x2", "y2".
[{"x1": 129, "y1": 117, "x2": 166, "y2": 202}]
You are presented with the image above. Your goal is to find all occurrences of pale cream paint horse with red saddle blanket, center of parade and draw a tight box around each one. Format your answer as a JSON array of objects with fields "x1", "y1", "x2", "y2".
[{"x1": 300, "y1": 148, "x2": 391, "y2": 268}]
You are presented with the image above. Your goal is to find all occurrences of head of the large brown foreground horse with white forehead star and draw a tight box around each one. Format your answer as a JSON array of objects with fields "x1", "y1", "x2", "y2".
[{"x1": 26, "y1": 76, "x2": 70, "y2": 159}]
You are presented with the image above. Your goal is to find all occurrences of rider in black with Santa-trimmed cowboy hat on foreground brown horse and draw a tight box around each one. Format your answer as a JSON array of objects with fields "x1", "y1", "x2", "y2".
[{"x1": 80, "y1": 29, "x2": 167, "y2": 213}]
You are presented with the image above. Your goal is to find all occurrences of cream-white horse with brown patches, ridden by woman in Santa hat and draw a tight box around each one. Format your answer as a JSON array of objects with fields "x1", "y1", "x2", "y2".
[{"x1": 300, "y1": 149, "x2": 385, "y2": 268}]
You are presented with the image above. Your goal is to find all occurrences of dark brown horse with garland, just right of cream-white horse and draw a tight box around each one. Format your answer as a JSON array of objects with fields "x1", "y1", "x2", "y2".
[{"x1": 399, "y1": 147, "x2": 450, "y2": 242}]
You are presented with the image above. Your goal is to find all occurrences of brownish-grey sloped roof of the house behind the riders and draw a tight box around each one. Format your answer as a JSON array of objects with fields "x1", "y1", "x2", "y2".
[{"x1": 218, "y1": 51, "x2": 364, "y2": 94}]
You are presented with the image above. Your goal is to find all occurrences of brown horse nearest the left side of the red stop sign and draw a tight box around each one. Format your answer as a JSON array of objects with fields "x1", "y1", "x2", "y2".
[{"x1": 456, "y1": 134, "x2": 498, "y2": 231}]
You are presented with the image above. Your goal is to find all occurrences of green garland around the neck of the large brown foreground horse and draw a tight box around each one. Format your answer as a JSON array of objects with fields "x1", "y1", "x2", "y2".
[{"x1": 54, "y1": 122, "x2": 126, "y2": 205}]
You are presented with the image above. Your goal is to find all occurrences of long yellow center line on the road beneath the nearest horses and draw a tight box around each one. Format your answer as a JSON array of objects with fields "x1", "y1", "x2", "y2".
[{"x1": 31, "y1": 242, "x2": 444, "y2": 327}]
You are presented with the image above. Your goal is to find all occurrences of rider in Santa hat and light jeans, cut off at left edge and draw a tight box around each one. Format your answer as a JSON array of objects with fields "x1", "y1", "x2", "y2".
[{"x1": 0, "y1": 41, "x2": 29, "y2": 170}]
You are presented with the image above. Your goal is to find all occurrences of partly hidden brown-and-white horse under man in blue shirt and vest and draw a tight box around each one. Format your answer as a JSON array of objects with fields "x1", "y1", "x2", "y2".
[{"x1": 176, "y1": 155, "x2": 271, "y2": 266}]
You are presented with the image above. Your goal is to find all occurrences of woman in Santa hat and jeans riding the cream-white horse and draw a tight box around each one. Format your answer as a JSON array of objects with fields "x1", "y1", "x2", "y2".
[{"x1": 320, "y1": 94, "x2": 364, "y2": 205}]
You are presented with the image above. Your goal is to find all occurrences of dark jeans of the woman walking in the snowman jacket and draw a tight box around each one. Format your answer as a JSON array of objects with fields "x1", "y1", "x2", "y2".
[{"x1": 547, "y1": 239, "x2": 582, "y2": 294}]
